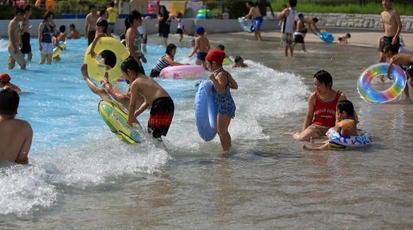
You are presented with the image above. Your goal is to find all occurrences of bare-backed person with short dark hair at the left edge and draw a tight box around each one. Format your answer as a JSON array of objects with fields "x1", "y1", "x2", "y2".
[{"x1": 0, "y1": 89, "x2": 33, "y2": 164}]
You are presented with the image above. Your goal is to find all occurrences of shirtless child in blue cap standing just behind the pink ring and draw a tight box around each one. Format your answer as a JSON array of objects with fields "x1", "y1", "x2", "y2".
[{"x1": 188, "y1": 26, "x2": 211, "y2": 68}]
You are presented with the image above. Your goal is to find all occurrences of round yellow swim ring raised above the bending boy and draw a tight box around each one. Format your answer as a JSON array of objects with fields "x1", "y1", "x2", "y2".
[{"x1": 84, "y1": 37, "x2": 129, "y2": 83}]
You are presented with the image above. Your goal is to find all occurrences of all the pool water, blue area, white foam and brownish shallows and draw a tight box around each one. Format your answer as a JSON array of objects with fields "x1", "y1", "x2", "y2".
[{"x1": 0, "y1": 34, "x2": 413, "y2": 230}]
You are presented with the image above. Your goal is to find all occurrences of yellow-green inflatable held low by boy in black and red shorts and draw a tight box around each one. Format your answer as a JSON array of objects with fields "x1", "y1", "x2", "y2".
[{"x1": 98, "y1": 100, "x2": 141, "y2": 145}]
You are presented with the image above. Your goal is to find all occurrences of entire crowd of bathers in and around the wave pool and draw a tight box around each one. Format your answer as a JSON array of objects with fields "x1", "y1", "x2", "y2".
[{"x1": 0, "y1": 0, "x2": 413, "y2": 163}]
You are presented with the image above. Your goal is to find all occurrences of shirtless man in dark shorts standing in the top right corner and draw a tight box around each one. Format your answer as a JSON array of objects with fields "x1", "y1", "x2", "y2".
[{"x1": 378, "y1": 0, "x2": 402, "y2": 62}]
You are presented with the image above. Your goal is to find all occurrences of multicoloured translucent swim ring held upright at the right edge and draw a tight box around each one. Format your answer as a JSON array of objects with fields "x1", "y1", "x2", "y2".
[{"x1": 357, "y1": 63, "x2": 407, "y2": 103}]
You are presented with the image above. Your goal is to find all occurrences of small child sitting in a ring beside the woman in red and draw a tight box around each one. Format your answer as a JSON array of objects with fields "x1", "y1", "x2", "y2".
[{"x1": 303, "y1": 100, "x2": 358, "y2": 150}]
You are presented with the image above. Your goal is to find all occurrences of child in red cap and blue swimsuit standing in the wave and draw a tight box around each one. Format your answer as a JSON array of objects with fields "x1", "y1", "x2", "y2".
[{"x1": 205, "y1": 49, "x2": 238, "y2": 153}]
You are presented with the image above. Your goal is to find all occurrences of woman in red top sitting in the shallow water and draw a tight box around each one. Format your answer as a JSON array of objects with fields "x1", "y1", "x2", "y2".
[{"x1": 286, "y1": 70, "x2": 347, "y2": 141}]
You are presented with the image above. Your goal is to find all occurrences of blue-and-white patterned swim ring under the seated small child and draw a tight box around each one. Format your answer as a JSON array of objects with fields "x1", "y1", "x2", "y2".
[{"x1": 326, "y1": 129, "x2": 373, "y2": 147}]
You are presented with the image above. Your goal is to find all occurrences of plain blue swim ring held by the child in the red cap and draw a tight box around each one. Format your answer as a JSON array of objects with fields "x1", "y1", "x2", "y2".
[{"x1": 195, "y1": 80, "x2": 218, "y2": 141}]
